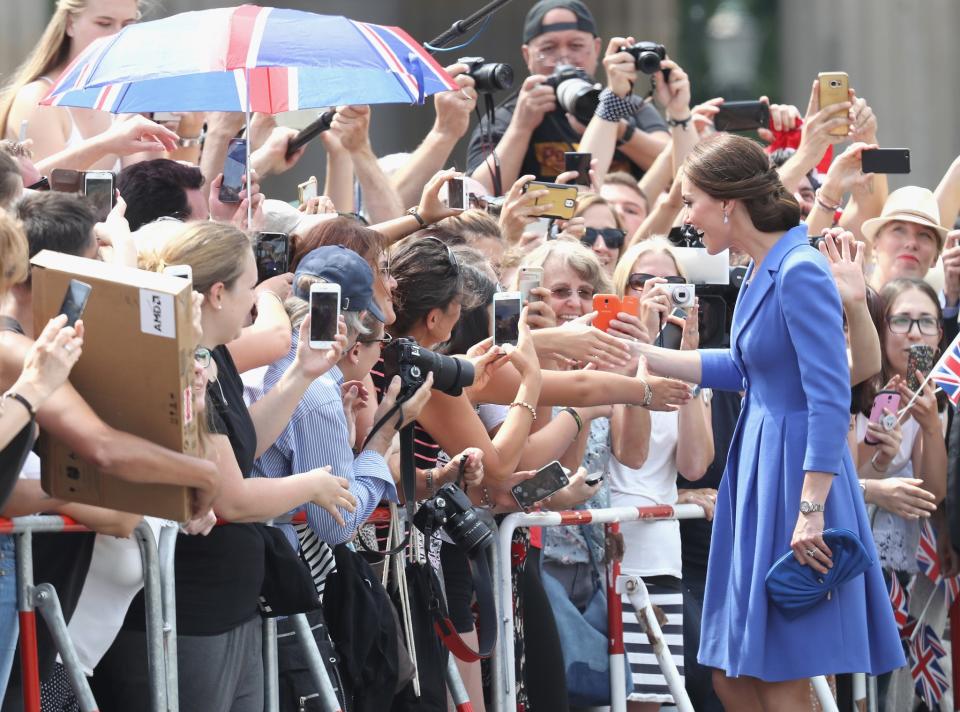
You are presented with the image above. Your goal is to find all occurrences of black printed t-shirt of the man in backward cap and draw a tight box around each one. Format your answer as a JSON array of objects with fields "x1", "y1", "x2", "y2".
[{"x1": 467, "y1": 94, "x2": 668, "y2": 184}]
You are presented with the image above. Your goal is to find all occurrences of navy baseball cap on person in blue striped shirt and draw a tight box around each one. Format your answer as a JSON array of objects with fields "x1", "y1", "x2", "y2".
[{"x1": 293, "y1": 245, "x2": 386, "y2": 322}]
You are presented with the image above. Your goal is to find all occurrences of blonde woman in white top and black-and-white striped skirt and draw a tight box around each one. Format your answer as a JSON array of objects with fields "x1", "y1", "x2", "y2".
[{"x1": 609, "y1": 238, "x2": 713, "y2": 712}]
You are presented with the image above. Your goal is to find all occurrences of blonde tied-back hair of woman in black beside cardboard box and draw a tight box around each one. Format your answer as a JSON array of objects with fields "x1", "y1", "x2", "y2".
[{"x1": 140, "y1": 222, "x2": 253, "y2": 294}]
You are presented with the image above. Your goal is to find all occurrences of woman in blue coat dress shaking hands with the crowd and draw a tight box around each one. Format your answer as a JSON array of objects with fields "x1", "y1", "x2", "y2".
[{"x1": 643, "y1": 135, "x2": 904, "y2": 712}]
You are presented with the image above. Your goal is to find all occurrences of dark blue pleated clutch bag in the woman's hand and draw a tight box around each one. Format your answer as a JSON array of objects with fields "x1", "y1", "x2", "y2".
[{"x1": 766, "y1": 529, "x2": 873, "y2": 618}]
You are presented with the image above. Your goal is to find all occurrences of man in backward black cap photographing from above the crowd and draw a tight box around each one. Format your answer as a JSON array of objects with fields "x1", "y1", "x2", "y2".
[{"x1": 467, "y1": 0, "x2": 670, "y2": 193}]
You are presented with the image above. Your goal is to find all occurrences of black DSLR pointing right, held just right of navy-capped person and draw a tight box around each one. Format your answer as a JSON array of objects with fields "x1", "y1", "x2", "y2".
[{"x1": 383, "y1": 337, "x2": 474, "y2": 401}]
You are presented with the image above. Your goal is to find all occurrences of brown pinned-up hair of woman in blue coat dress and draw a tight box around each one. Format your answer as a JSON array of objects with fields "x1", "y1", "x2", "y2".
[{"x1": 683, "y1": 133, "x2": 800, "y2": 232}]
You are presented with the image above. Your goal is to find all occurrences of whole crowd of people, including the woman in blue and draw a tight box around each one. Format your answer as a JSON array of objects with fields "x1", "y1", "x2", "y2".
[{"x1": 0, "y1": 0, "x2": 960, "y2": 712}]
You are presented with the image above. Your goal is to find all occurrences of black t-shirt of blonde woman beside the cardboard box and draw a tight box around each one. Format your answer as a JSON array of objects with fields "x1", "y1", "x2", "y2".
[{"x1": 125, "y1": 346, "x2": 264, "y2": 635}]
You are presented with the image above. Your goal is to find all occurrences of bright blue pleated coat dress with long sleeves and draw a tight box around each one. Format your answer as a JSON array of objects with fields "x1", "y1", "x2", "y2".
[{"x1": 698, "y1": 225, "x2": 904, "y2": 682}]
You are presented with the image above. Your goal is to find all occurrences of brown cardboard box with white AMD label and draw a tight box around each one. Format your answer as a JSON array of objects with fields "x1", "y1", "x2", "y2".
[{"x1": 31, "y1": 250, "x2": 198, "y2": 521}]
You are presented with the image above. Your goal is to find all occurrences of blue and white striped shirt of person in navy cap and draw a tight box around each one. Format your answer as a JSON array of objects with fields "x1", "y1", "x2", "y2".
[{"x1": 243, "y1": 331, "x2": 397, "y2": 548}]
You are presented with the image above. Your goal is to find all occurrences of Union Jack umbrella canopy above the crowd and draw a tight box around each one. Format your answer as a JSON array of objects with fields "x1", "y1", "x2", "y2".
[{"x1": 41, "y1": 5, "x2": 457, "y2": 114}]
